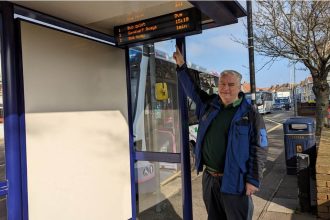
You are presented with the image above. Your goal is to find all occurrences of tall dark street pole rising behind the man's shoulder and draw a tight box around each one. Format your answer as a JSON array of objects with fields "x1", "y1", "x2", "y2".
[{"x1": 246, "y1": 0, "x2": 256, "y2": 105}]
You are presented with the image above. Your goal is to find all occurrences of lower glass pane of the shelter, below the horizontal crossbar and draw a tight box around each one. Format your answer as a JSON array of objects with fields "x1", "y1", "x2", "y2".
[{"x1": 135, "y1": 161, "x2": 183, "y2": 220}]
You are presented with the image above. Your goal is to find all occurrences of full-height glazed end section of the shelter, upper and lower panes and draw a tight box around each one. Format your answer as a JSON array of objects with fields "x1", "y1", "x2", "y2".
[{"x1": 129, "y1": 40, "x2": 183, "y2": 220}]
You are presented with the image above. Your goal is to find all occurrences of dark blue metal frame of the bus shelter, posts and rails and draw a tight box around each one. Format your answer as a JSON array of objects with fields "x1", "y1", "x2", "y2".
[{"x1": 0, "y1": 2, "x2": 246, "y2": 220}]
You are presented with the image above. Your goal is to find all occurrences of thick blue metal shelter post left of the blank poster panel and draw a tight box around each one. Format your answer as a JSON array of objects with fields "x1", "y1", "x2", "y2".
[{"x1": 1, "y1": 2, "x2": 22, "y2": 220}]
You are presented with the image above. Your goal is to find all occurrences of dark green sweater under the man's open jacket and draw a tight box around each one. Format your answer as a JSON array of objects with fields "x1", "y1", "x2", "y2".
[{"x1": 202, "y1": 99, "x2": 242, "y2": 173}]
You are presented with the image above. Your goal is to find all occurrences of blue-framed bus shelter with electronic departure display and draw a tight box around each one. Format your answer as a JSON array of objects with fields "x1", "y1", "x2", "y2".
[{"x1": 0, "y1": 1, "x2": 246, "y2": 220}]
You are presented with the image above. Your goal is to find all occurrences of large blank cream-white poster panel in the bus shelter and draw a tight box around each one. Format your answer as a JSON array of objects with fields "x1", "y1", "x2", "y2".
[{"x1": 21, "y1": 22, "x2": 131, "y2": 220}]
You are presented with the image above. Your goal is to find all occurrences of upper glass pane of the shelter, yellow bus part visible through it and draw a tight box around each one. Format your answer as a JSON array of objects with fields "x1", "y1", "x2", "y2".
[{"x1": 129, "y1": 40, "x2": 180, "y2": 153}]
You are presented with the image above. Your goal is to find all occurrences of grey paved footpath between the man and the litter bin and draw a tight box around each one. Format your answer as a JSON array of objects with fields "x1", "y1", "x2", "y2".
[{"x1": 253, "y1": 112, "x2": 317, "y2": 220}]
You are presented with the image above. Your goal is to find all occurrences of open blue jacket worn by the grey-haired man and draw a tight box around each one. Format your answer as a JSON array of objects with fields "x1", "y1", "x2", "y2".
[{"x1": 177, "y1": 64, "x2": 268, "y2": 195}]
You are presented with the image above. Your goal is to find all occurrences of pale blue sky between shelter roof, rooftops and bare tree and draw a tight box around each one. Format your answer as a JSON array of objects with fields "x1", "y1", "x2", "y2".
[{"x1": 186, "y1": 17, "x2": 310, "y2": 88}]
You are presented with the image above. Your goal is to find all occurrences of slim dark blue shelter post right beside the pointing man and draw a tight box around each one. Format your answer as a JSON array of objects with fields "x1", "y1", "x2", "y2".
[{"x1": 176, "y1": 38, "x2": 193, "y2": 220}]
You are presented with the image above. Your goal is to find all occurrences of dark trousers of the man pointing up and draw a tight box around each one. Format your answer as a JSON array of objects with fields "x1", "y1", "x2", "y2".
[{"x1": 202, "y1": 170, "x2": 253, "y2": 220}]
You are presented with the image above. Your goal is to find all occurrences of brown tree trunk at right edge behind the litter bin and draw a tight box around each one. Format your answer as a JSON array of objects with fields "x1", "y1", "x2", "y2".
[{"x1": 313, "y1": 77, "x2": 330, "y2": 136}]
